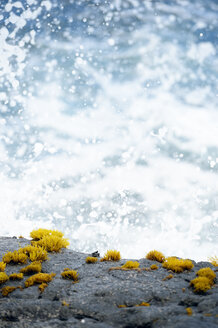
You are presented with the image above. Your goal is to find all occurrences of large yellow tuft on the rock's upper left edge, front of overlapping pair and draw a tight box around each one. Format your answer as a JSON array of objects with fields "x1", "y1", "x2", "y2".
[{"x1": 32, "y1": 235, "x2": 69, "y2": 252}]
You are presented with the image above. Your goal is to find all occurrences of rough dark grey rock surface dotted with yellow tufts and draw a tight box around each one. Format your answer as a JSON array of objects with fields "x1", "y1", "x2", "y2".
[{"x1": 0, "y1": 237, "x2": 218, "y2": 328}]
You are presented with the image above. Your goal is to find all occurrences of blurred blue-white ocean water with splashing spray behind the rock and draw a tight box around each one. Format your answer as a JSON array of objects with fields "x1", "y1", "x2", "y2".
[{"x1": 0, "y1": 0, "x2": 218, "y2": 260}]
